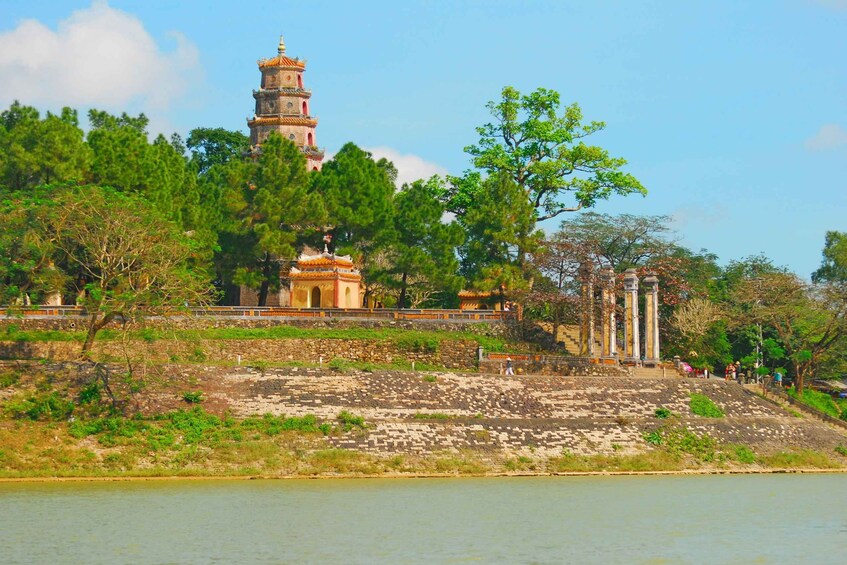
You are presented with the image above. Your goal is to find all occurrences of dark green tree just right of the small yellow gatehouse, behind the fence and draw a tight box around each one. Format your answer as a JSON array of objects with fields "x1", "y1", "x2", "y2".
[{"x1": 378, "y1": 178, "x2": 464, "y2": 308}]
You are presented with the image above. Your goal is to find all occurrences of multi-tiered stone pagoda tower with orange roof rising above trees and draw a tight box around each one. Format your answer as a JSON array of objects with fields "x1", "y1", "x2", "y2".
[{"x1": 247, "y1": 36, "x2": 324, "y2": 171}]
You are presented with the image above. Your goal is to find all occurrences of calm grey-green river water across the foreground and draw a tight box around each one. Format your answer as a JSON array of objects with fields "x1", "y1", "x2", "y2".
[{"x1": 0, "y1": 474, "x2": 847, "y2": 564}]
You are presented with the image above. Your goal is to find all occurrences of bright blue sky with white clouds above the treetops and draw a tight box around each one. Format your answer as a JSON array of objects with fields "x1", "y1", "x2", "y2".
[{"x1": 0, "y1": 0, "x2": 847, "y2": 276}]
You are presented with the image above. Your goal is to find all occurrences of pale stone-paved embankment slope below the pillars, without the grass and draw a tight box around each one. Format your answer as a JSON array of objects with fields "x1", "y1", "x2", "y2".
[{"x1": 199, "y1": 368, "x2": 847, "y2": 456}]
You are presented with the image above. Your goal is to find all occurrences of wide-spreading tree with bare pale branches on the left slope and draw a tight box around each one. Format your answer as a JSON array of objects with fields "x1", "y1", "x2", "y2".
[{"x1": 33, "y1": 186, "x2": 211, "y2": 356}]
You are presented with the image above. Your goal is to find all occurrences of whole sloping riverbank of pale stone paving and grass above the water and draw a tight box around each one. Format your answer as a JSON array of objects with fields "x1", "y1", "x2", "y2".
[{"x1": 0, "y1": 362, "x2": 847, "y2": 479}]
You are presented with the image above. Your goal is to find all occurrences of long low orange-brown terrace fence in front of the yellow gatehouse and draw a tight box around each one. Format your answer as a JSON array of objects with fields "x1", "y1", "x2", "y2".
[{"x1": 2, "y1": 306, "x2": 517, "y2": 322}]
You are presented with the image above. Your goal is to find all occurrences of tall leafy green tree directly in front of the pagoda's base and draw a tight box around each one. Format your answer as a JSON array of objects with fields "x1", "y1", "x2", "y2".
[{"x1": 219, "y1": 134, "x2": 326, "y2": 306}]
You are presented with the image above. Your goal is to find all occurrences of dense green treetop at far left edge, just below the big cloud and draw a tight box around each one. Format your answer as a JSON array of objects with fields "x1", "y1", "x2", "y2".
[{"x1": 0, "y1": 101, "x2": 90, "y2": 190}]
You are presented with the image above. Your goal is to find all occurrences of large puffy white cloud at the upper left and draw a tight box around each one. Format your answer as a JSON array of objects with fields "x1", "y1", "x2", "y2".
[{"x1": 0, "y1": 1, "x2": 200, "y2": 120}]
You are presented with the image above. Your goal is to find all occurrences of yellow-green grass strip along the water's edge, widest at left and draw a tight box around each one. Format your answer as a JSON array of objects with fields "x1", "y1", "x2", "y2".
[{"x1": 0, "y1": 407, "x2": 845, "y2": 478}]
